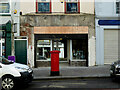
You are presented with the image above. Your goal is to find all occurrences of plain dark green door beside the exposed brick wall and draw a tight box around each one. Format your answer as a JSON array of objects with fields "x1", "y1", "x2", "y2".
[{"x1": 15, "y1": 40, "x2": 27, "y2": 64}]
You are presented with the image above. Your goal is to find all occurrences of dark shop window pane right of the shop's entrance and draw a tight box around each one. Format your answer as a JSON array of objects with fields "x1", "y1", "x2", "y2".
[{"x1": 72, "y1": 39, "x2": 87, "y2": 60}]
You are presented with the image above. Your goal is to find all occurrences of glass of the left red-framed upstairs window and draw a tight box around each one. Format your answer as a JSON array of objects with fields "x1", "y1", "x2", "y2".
[{"x1": 38, "y1": 3, "x2": 50, "y2": 12}]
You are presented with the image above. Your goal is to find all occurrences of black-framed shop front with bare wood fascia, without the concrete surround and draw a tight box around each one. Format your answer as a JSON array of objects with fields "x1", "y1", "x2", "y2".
[{"x1": 34, "y1": 27, "x2": 88, "y2": 67}]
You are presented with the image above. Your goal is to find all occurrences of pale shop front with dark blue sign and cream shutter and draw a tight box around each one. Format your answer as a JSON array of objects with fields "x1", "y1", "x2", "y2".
[{"x1": 96, "y1": 18, "x2": 120, "y2": 65}]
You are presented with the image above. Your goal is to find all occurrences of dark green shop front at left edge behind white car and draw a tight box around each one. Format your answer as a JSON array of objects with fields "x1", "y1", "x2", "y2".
[{"x1": 0, "y1": 21, "x2": 11, "y2": 58}]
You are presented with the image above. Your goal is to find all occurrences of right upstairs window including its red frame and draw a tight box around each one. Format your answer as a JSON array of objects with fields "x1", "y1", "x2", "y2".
[{"x1": 65, "y1": 0, "x2": 80, "y2": 13}]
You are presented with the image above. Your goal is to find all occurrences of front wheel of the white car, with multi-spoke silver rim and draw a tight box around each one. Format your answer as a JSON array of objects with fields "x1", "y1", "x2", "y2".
[{"x1": 2, "y1": 76, "x2": 15, "y2": 90}]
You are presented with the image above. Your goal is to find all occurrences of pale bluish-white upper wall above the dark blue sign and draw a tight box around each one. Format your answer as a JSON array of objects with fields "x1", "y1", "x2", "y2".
[{"x1": 95, "y1": 0, "x2": 119, "y2": 17}]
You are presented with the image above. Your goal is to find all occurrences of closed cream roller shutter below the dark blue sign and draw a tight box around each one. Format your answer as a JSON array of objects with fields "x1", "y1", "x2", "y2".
[{"x1": 104, "y1": 30, "x2": 119, "y2": 64}]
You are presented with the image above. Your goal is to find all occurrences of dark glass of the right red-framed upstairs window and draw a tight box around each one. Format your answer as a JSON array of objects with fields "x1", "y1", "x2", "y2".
[{"x1": 66, "y1": 3, "x2": 78, "y2": 13}]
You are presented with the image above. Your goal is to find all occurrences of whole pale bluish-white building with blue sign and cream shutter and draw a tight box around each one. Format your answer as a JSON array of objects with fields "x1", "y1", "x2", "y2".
[{"x1": 95, "y1": 0, "x2": 120, "y2": 65}]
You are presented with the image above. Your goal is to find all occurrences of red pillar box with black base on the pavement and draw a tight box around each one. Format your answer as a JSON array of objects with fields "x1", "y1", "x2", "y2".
[{"x1": 50, "y1": 50, "x2": 60, "y2": 76}]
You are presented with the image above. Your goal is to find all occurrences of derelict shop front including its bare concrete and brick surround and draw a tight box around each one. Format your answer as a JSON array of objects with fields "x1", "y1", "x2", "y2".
[{"x1": 20, "y1": 14, "x2": 96, "y2": 67}]
